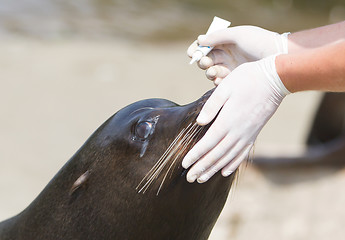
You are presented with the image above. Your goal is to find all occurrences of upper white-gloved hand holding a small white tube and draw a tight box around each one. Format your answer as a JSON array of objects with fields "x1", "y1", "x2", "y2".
[{"x1": 187, "y1": 26, "x2": 289, "y2": 85}]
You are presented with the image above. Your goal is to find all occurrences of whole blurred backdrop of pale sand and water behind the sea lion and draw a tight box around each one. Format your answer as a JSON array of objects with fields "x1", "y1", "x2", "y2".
[{"x1": 0, "y1": 0, "x2": 345, "y2": 240}]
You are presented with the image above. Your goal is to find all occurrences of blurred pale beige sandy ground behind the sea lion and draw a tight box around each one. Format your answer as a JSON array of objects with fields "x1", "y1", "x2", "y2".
[{"x1": 0, "y1": 40, "x2": 345, "y2": 240}]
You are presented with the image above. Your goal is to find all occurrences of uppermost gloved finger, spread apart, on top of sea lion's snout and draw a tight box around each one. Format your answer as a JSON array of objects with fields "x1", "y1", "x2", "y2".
[{"x1": 196, "y1": 81, "x2": 230, "y2": 125}]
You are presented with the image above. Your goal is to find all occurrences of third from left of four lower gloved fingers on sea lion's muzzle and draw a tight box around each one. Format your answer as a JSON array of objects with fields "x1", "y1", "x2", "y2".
[{"x1": 198, "y1": 142, "x2": 246, "y2": 183}]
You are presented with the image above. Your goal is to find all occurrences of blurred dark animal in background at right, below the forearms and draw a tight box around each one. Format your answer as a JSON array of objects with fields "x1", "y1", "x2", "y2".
[{"x1": 253, "y1": 93, "x2": 345, "y2": 168}]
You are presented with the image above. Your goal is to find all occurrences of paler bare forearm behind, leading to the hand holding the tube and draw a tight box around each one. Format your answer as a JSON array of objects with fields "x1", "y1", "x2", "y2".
[{"x1": 288, "y1": 21, "x2": 345, "y2": 53}]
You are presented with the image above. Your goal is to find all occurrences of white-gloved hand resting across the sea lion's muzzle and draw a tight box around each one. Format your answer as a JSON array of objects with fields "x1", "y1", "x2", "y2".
[{"x1": 182, "y1": 55, "x2": 289, "y2": 183}]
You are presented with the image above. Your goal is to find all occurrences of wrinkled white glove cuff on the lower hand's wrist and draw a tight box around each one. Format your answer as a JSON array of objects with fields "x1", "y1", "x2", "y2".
[{"x1": 260, "y1": 54, "x2": 290, "y2": 102}]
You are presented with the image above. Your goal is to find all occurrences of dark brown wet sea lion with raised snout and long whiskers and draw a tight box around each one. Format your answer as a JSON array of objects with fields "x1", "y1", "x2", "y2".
[{"x1": 0, "y1": 91, "x2": 235, "y2": 240}]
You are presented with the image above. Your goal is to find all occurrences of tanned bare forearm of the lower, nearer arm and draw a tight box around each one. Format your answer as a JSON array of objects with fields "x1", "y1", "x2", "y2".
[{"x1": 276, "y1": 40, "x2": 345, "y2": 92}]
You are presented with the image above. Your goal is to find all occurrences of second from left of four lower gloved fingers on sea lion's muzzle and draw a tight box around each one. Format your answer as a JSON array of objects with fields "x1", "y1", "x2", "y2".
[{"x1": 187, "y1": 135, "x2": 236, "y2": 182}]
